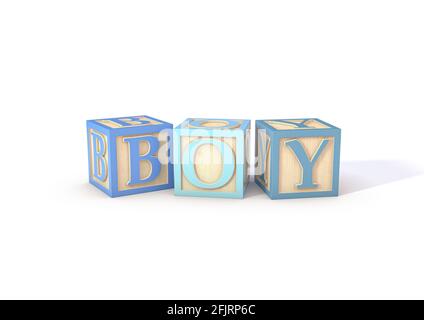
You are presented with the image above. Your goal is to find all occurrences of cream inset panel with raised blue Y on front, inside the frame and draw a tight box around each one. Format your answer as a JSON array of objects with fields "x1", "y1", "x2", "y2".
[{"x1": 278, "y1": 137, "x2": 334, "y2": 193}]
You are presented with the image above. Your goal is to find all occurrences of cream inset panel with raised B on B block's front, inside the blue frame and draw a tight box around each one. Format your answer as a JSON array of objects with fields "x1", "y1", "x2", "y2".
[{"x1": 116, "y1": 133, "x2": 169, "y2": 191}]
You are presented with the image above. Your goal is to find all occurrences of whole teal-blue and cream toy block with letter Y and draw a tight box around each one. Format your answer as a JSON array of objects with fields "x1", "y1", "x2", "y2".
[{"x1": 255, "y1": 119, "x2": 341, "y2": 199}]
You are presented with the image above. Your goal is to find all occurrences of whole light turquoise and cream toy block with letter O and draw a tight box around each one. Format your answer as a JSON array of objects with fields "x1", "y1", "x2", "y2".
[{"x1": 174, "y1": 118, "x2": 250, "y2": 198}]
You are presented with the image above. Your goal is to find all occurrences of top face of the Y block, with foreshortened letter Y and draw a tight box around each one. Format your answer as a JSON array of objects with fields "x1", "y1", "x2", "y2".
[{"x1": 258, "y1": 118, "x2": 338, "y2": 131}]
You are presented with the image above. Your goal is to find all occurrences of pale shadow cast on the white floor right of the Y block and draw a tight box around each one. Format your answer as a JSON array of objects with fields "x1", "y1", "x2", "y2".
[{"x1": 340, "y1": 160, "x2": 424, "y2": 195}]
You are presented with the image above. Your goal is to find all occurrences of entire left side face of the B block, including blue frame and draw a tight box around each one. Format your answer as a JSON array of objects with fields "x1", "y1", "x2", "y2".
[{"x1": 87, "y1": 121, "x2": 112, "y2": 194}]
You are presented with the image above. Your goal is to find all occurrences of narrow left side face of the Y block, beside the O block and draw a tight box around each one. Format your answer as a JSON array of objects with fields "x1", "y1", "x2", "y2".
[{"x1": 255, "y1": 126, "x2": 271, "y2": 191}]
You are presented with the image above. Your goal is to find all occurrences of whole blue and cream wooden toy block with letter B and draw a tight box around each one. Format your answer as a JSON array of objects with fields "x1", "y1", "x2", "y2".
[{"x1": 87, "y1": 116, "x2": 174, "y2": 197}]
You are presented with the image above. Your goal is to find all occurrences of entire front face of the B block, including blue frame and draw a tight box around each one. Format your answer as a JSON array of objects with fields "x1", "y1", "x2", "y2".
[{"x1": 111, "y1": 130, "x2": 173, "y2": 196}]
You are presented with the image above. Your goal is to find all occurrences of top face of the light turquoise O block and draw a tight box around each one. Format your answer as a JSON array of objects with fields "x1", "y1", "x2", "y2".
[{"x1": 177, "y1": 118, "x2": 250, "y2": 130}]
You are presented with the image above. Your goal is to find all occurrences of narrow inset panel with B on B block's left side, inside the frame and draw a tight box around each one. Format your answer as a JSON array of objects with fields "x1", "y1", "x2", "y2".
[{"x1": 88, "y1": 128, "x2": 110, "y2": 190}]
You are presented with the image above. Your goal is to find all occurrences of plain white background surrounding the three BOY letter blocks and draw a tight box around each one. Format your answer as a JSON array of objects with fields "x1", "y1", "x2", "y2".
[{"x1": 0, "y1": 0, "x2": 424, "y2": 299}]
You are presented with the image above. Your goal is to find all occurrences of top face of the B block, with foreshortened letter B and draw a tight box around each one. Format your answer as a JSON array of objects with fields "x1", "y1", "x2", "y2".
[{"x1": 89, "y1": 115, "x2": 170, "y2": 129}]
